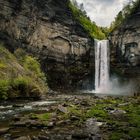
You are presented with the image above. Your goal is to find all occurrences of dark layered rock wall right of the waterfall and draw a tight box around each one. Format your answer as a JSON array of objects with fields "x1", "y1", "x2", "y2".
[{"x1": 110, "y1": 8, "x2": 140, "y2": 91}]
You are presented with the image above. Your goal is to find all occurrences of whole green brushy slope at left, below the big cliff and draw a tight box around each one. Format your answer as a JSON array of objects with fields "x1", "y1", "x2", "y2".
[{"x1": 0, "y1": 44, "x2": 47, "y2": 100}]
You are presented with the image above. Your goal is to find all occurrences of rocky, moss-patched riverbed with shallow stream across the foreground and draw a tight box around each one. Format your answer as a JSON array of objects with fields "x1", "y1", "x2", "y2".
[{"x1": 0, "y1": 94, "x2": 140, "y2": 140}]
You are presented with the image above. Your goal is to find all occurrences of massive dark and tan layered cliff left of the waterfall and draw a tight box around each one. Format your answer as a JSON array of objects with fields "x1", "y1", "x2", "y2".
[{"x1": 0, "y1": 0, "x2": 93, "y2": 88}]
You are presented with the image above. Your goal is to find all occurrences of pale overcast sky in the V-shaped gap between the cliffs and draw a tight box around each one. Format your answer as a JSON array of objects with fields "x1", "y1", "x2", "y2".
[{"x1": 77, "y1": 0, "x2": 131, "y2": 26}]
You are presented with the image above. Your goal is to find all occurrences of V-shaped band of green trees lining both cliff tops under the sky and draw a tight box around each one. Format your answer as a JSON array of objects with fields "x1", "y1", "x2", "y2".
[{"x1": 69, "y1": 0, "x2": 140, "y2": 36}]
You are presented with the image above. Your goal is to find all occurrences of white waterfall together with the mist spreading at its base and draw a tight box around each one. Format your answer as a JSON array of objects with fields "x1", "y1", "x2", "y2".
[{"x1": 86, "y1": 40, "x2": 136, "y2": 95}]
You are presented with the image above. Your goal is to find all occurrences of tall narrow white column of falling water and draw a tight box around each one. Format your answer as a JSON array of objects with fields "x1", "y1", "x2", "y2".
[{"x1": 95, "y1": 40, "x2": 110, "y2": 92}]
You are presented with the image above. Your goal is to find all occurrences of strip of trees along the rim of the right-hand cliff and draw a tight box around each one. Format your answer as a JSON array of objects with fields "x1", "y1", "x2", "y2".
[{"x1": 110, "y1": 0, "x2": 140, "y2": 32}]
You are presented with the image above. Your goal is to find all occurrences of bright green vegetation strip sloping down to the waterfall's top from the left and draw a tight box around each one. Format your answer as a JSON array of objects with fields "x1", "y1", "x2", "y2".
[{"x1": 68, "y1": 1, "x2": 106, "y2": 40}]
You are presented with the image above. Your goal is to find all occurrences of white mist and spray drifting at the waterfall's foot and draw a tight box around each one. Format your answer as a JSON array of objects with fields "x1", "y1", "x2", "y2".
[{"x1": 87, "y1": 72, "x2": 137, "y2": 96}]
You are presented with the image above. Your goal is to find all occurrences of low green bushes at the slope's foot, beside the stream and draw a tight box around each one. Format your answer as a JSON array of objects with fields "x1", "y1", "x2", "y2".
[{"x1": 0, "y1": 77, "x2": 43, "y2": 100}]
